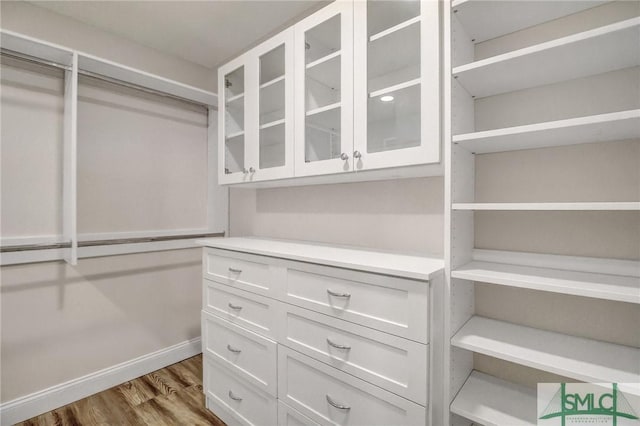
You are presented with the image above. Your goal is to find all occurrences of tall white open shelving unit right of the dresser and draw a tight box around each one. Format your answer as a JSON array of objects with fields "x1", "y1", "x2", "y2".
[{"x1": 443, "y1": 0, "x2": 640, "y2": 425}]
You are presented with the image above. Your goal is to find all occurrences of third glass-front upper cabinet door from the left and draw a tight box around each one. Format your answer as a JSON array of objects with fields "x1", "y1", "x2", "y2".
[{"x1": 294, "y1": 0, "x2": 353, "y2": 176}]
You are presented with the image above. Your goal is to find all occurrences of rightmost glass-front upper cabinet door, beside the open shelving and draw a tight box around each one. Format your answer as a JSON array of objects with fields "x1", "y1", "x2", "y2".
[{"x1": 352, "y1": 0, "x2": 441, "y2": 171}]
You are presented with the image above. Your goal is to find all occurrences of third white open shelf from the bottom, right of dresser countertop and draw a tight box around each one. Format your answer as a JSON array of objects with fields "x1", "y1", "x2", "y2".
[{"x1": 451, "y1": 255, "x2": 640, "y2": 303}]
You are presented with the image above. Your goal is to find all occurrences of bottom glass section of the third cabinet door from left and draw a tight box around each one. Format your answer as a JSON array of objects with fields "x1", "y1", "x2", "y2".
[{"x1": 305, "y1": 108, "x2": 341, "y2": 163}]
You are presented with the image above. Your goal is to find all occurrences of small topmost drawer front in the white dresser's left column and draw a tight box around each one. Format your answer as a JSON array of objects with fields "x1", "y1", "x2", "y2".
[{"x1": 203, "y1": 248, "x2": 283, "y2": 297}]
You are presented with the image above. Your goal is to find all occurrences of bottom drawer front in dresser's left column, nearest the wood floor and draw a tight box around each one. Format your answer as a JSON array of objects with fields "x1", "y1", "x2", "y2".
[{"x1": 203, "y1": 356, "x2": 278, "y2": 426}]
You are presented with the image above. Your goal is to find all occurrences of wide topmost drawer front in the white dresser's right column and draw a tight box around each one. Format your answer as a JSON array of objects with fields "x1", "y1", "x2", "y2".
[{"x1": 284, "y1": 262, "x2": 429, "y2": 343}]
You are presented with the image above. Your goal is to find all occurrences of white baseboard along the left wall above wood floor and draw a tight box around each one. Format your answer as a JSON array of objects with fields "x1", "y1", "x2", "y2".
[{"x1": 0, "y1": 337, "x2": 202, "y2": 425}]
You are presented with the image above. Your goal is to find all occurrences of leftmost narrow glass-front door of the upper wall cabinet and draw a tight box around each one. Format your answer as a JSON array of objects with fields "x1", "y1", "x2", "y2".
[{"x1": 218, "y1": 56, "x2": 249, "y2": 184}]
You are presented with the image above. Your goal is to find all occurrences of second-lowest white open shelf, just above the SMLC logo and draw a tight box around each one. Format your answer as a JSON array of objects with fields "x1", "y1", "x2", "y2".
[{"x1": 451, "y1": 316, "x2": 640, "y2": 393}]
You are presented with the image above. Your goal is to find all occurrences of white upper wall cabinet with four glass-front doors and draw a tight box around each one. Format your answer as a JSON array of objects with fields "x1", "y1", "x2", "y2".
[{"x1": 218, "y1": 0, "x2": 441, "y2": 184}]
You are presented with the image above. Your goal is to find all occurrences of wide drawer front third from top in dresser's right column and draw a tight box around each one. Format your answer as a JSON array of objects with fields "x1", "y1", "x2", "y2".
[{"x1": 278, "y1": 347, "x2": 427, "y2": 426}]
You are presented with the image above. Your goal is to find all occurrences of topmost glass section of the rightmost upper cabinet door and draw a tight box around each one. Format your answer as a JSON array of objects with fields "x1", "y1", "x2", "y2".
[{"x1": 367, "y1": 0, "x2": 420, "y2": 37}]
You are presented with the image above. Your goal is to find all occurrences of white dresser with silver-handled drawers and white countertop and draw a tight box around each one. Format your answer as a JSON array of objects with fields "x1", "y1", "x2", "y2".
[{"x1": 200, "y1": 238, "x2": 444, "y2": 426}]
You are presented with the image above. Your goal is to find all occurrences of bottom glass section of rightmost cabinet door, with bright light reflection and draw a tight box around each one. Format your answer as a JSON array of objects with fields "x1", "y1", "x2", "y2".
[{"x1": 367, "y1": 84, "x2": 420, "y2": 153}]
